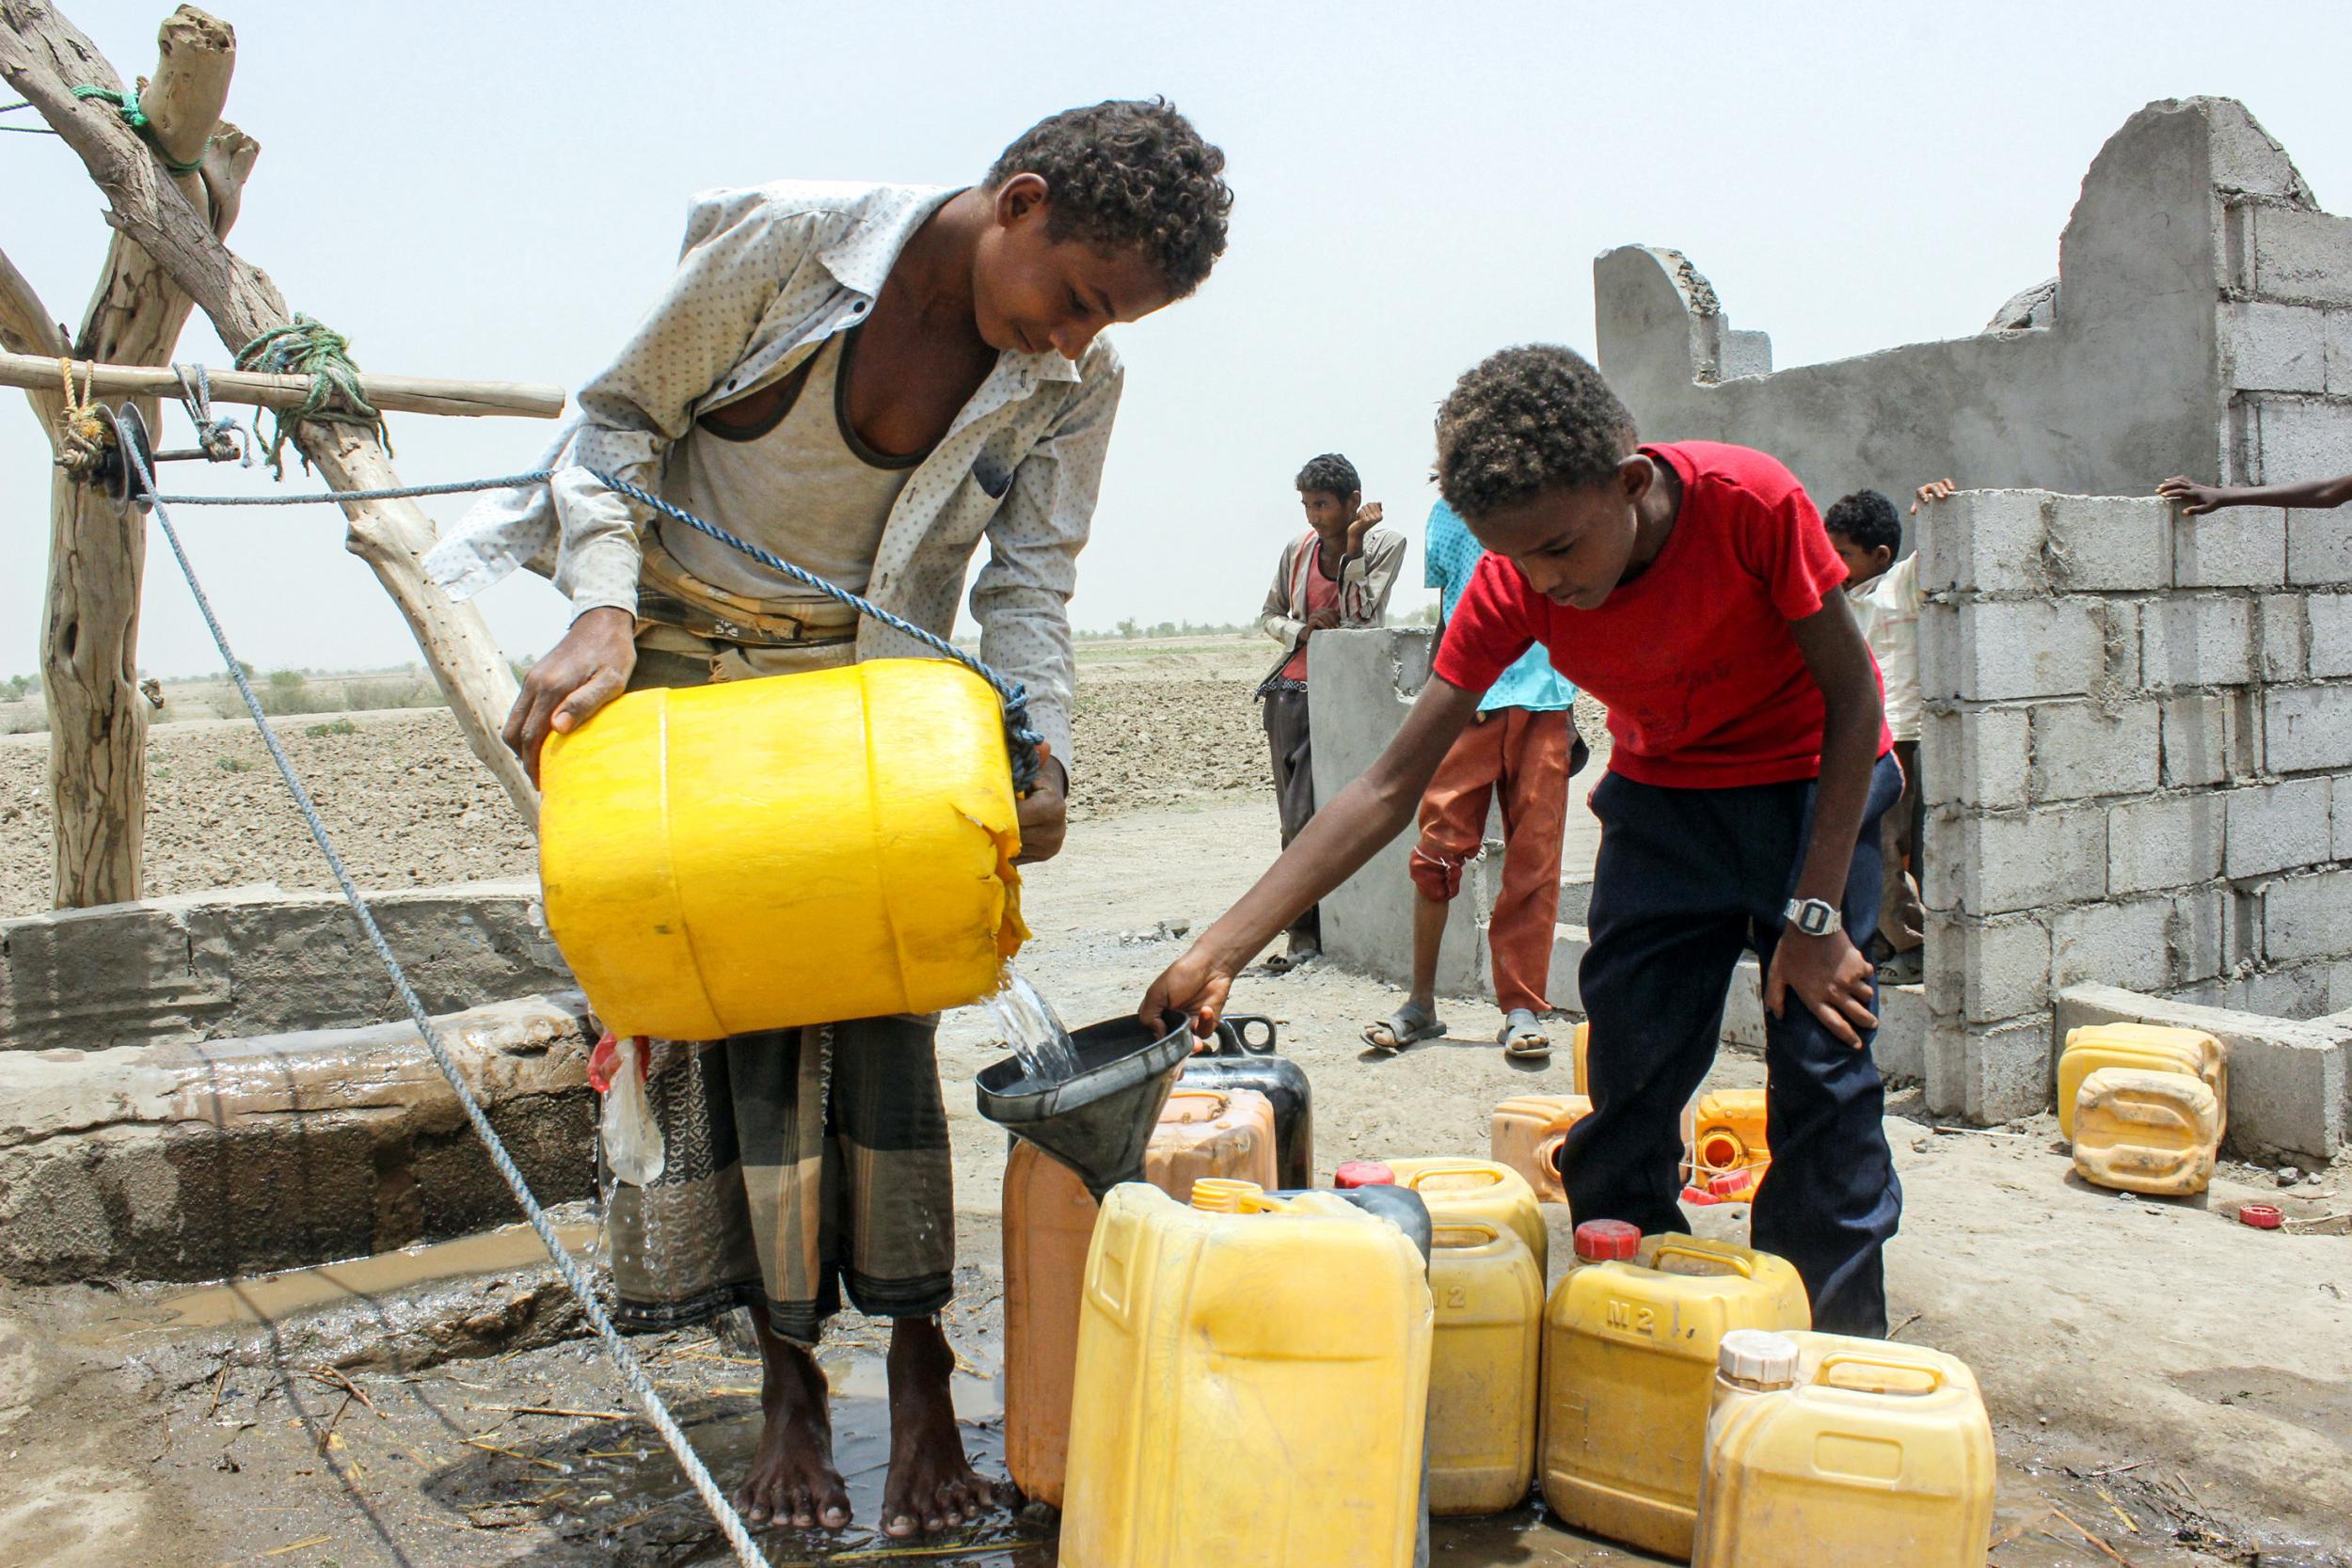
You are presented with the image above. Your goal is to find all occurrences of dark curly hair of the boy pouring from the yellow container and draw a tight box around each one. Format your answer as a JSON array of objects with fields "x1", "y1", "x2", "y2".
[{"x1": 988, "y1": 99, "x2": 1232, "y2": 298}]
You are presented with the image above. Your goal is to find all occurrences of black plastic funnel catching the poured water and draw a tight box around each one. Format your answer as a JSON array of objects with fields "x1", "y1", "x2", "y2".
[{"x1": 977, "y1": 1018, "x2": 1193, "y2": 1199}]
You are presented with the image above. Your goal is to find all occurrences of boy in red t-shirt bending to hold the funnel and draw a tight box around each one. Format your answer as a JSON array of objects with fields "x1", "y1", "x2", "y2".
[{"x1": 1141, "y1": 345, "x2": 1903, "y2": 1336}]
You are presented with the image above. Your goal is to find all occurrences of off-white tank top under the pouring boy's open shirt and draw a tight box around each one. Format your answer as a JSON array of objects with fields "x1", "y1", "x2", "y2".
[{"x1": 657, "y1": 326, "x2": 927, "y2": 602}]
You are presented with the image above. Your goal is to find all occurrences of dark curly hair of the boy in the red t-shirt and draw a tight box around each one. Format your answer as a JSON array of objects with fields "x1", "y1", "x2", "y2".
[{"x1": 1438, "y1": 343, "x2": 1635, "y2": 522}]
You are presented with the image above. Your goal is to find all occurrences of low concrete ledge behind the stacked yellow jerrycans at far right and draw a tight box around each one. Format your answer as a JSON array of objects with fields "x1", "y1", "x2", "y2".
[{"x1": 2056, "y1": 985, "x2": 2352, "y2": 1162}]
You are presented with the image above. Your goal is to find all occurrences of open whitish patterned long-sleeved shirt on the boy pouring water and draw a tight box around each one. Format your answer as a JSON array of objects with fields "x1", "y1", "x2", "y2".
[{"x1": 426, "y1": 181, "x2": 1124, "y2": 762}]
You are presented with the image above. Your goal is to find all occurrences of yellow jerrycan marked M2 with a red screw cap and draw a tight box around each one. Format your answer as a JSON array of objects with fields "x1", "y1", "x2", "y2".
[{"x1": 1543, "y1": 1234, "x2": 1814, "y2": 1557}]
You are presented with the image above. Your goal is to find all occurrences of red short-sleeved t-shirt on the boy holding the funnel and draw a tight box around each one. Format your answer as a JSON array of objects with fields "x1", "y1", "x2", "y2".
[{"x1": 1438, "y1": 442, "x2": 1894, "y2": 790}]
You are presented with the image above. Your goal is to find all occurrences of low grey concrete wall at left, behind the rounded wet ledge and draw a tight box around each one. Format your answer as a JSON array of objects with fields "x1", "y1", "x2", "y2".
[{"x1": 0, "y1": 881, "x2": 572, "y2": 1051}]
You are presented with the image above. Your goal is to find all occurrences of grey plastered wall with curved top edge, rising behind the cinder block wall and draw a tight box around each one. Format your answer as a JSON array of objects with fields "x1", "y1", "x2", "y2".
[{"x1": 1593, "y1": 99, "x2": 2314, "y2": 526}]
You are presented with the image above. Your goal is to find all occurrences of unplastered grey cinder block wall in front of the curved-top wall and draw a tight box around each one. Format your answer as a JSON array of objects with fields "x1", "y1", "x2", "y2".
[{"x1": 1919, "y1": 491, "x2": 2352, "y2": 1119}]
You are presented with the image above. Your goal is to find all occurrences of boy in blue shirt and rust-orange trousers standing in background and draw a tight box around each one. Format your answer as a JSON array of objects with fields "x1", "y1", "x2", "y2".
[{"x1": 1364, "y1": 500, "x2": 1590, "y2": 1060}]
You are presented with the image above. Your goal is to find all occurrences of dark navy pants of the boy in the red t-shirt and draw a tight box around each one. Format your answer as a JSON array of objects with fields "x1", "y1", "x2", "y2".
[{"x1": 1560, "y1": 757, "x2": 1903, "y2": 1338}]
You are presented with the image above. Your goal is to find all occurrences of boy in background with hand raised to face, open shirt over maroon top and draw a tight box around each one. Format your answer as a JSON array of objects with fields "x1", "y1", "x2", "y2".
[{"x1": 1259, "y1": 451, "x2": 1405, "y2": 975}]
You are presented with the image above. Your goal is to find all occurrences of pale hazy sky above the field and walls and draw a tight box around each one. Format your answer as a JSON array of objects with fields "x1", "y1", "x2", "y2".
[{"x1": 0, "y1": 0, "x2": 2352, "y2": 674}]
